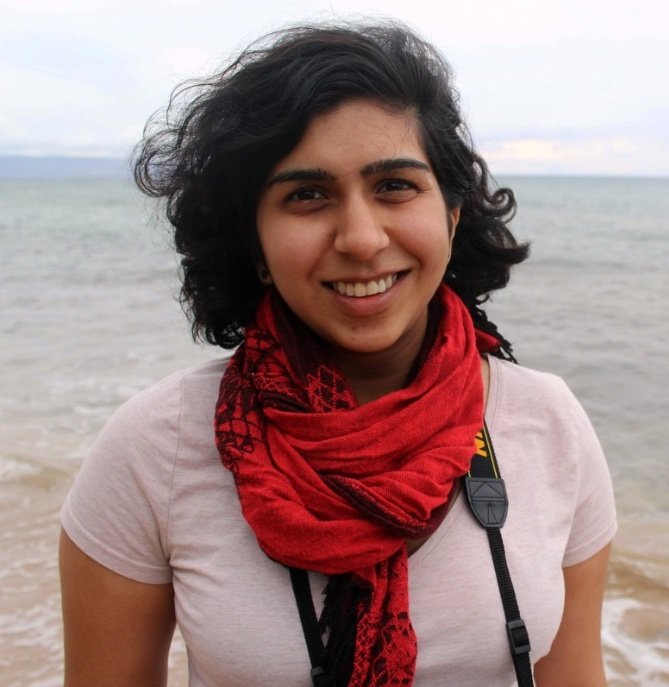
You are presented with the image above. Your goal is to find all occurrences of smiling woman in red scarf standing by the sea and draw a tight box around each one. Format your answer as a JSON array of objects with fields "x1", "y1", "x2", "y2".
[{"x1": 61, "y1": 25, "x2": 615, "y2": 687}]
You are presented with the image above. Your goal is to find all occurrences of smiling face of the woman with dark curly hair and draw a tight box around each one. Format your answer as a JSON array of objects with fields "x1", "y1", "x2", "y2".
[{"x1": 257, "y1": 100, "x2": 459, "y2": 364}]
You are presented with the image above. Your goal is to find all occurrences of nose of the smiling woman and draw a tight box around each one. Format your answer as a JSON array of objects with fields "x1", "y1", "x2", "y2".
[{"x1": 334, "y1": 197, "x2": 390, "y2": 260}]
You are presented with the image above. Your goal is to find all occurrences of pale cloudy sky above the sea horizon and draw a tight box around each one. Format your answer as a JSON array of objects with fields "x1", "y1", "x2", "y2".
[{"x1": 0, "y1": 0, "x2": 669, "y2": 176}]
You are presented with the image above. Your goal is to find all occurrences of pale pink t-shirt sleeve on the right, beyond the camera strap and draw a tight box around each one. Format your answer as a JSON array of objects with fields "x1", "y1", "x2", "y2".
[{"x1": 563, "y1": 382, "x2": 617, "y2": 567}]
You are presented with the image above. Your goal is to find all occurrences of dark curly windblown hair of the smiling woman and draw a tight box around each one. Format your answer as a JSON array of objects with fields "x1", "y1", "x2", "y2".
[{"x1": 134, "y1": 23, "x2": 528, "y2": 355}]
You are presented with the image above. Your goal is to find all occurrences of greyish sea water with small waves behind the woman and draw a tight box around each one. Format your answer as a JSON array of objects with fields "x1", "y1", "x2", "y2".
[{"x1": 0, "y1": 178, "x2": 669, "y2": 687}]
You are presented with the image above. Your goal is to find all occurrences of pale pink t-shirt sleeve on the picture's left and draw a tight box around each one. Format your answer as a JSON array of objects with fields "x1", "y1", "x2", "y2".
[{"x1": 61, "y1": 378, "x2": 181, "y2": 584}]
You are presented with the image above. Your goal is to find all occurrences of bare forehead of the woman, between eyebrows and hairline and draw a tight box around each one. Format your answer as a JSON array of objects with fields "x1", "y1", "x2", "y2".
[{"x1": 273, "y1": 100, "x2": 429, "y2": 172}]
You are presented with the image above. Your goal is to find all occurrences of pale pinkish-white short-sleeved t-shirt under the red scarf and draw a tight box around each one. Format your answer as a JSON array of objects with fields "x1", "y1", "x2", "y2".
[{"x1": 62, "y1": 358, "x2": 616, "y2": 687}]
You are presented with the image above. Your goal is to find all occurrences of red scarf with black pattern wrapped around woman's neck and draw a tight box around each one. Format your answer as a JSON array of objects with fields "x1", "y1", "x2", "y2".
[{"x1": 216, "y1": 286, "x2": 497, "y2": 687}]
